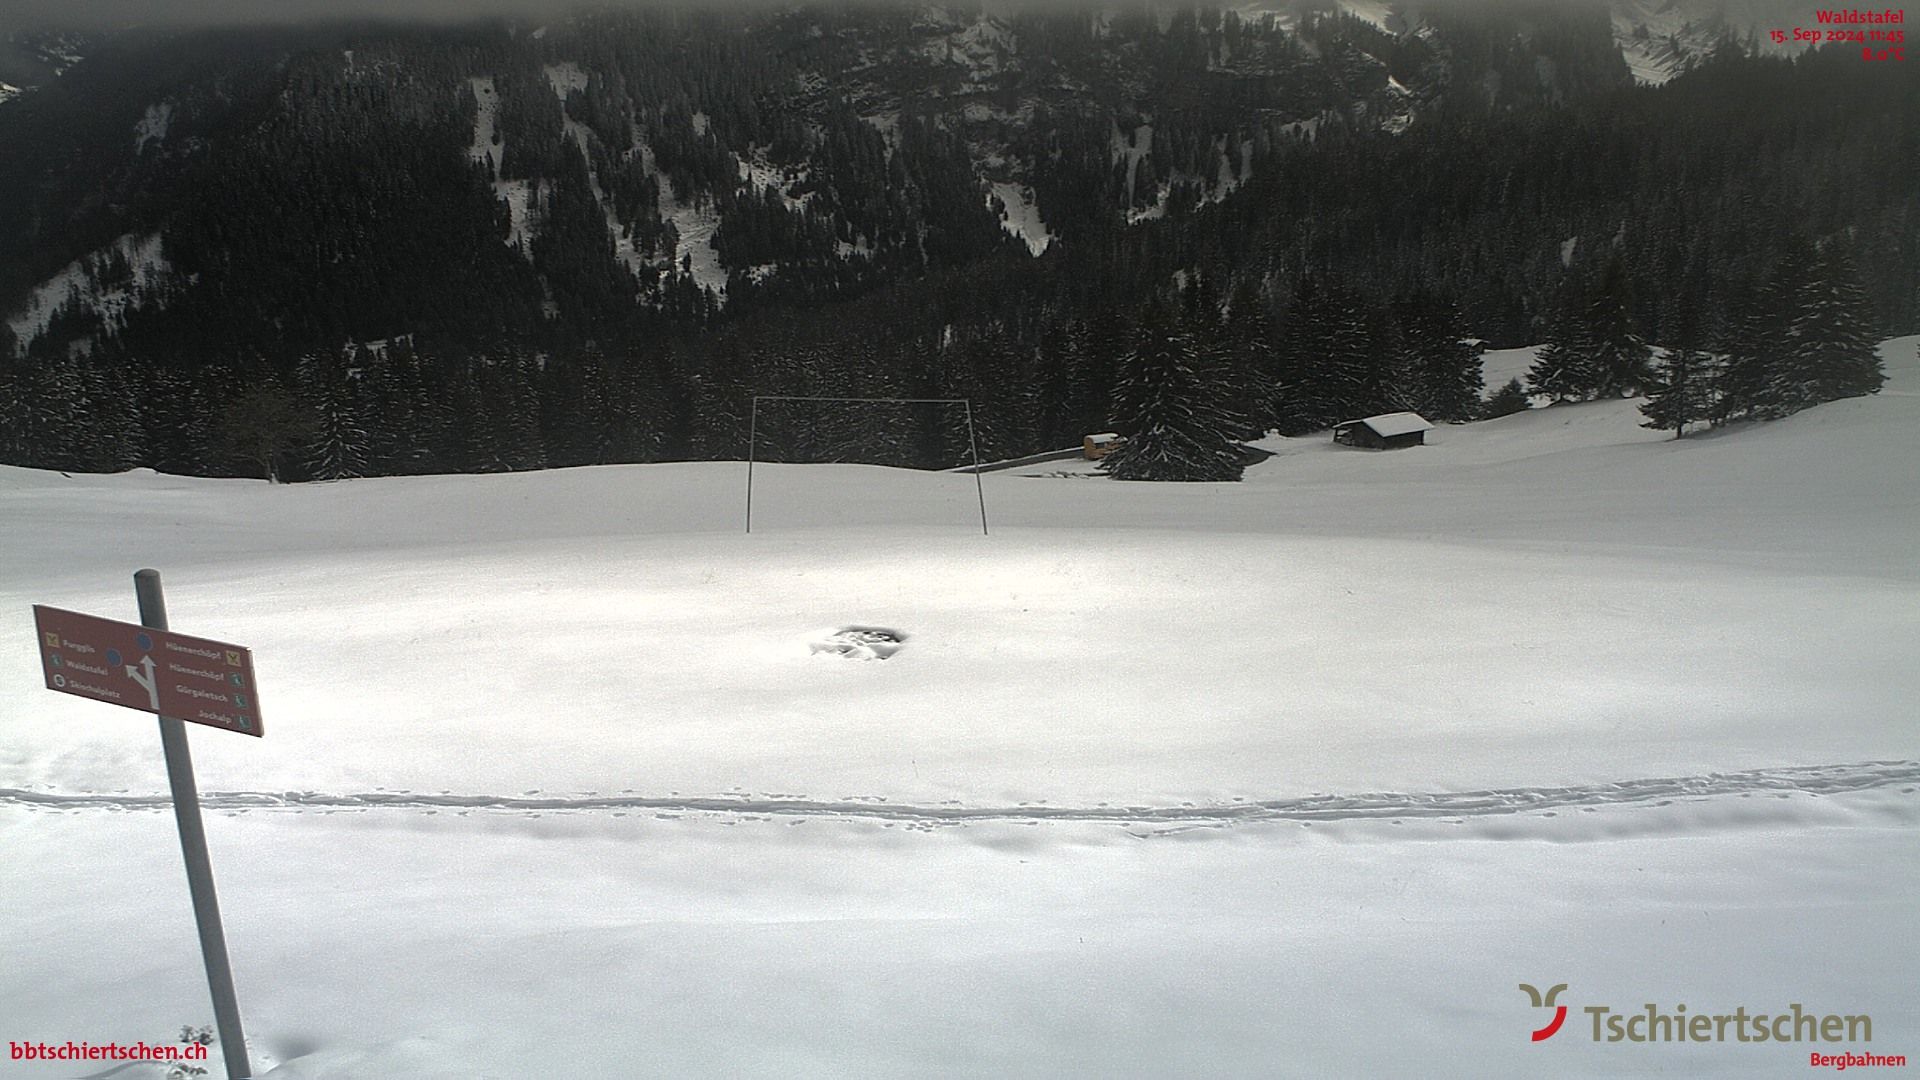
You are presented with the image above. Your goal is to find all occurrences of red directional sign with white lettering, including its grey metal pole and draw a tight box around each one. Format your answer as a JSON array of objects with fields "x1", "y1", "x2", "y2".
[{"x1": 33, "y1": 571, "x2": 261, "y2": 1080}]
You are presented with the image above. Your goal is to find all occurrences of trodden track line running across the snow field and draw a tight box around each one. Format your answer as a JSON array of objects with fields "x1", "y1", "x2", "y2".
[{"x1": 0, "y1": 761, "x2": 1920, "y2": 826}]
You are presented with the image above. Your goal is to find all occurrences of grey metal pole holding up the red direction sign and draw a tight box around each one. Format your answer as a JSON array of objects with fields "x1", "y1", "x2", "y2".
[{"x1": 132, "y1": 571, "x2": 253, "y2": 1080}]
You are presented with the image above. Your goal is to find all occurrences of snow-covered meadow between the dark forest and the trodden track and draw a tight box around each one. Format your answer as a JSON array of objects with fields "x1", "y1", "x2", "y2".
[{"x1": 0, "y1": 340, "x2": 1920, "y2": 803}]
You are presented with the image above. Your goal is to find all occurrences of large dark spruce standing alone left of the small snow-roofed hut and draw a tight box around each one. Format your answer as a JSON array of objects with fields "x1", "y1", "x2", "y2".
[{"x1": 1100, "y1": 306, "x2": 1246, "y2": 480}]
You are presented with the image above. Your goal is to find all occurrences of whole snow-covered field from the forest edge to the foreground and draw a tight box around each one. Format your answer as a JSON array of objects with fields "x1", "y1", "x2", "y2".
[{"x1": 0, "y1": 338, "x2": 1920, "y2": 1080}]
